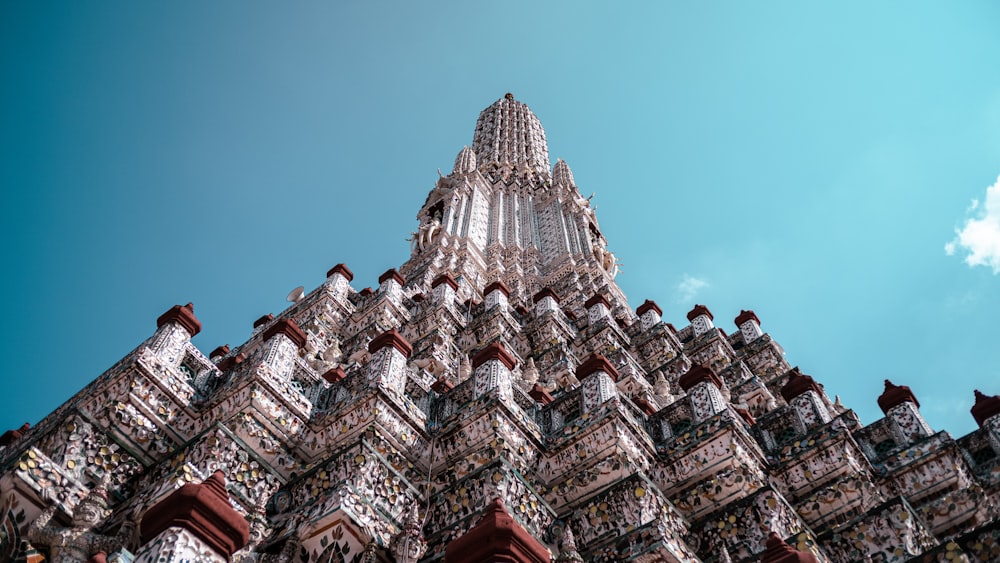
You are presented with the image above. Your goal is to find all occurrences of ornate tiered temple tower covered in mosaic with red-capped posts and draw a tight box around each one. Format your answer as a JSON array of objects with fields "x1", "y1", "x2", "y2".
[{"x1": 0, "y1": 94, "x2": 1000, "y2": 563}]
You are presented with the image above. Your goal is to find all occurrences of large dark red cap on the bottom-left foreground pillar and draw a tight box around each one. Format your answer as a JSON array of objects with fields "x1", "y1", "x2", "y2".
[{"x1": 141, "y1": 471, "x2": 250, "y2": 558}]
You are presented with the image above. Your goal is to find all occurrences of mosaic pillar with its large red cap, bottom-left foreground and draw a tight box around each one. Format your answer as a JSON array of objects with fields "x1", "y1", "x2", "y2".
[{"x1": 135, "y1": 471, "x2": 250, "y2": 563}]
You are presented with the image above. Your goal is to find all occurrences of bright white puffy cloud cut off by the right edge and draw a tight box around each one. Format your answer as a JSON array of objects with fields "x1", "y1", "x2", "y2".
[{"x1": 944, "y1": 177, "x2": 1000, "y2": 274}]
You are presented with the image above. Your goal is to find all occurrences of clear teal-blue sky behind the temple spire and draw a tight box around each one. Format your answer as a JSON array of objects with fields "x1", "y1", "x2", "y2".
[{"x1": 0, "y1": 1, "x2": 1000, "y2": 436}]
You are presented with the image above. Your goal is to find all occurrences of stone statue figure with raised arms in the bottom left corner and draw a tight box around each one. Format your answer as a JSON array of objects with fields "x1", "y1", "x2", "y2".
[{"x1": 27, "y1": 483, "x2": 135, "y2": 563}]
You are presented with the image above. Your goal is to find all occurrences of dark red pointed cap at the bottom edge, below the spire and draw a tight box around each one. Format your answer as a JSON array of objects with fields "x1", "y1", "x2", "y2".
[{"x1": 445, "y1": 498, "x2": 552, "y2": 563}]
